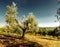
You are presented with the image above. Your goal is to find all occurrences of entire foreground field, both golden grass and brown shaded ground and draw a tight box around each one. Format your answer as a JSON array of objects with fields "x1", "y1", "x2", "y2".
[{"x1": 0, "y1": 34, "x2": 60, "y2": 47}]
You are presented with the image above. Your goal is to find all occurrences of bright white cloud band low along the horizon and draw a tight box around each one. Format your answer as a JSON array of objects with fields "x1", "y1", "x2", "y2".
[{"x1": 0, "y1": 22, "x2": 59, "y2": 27}]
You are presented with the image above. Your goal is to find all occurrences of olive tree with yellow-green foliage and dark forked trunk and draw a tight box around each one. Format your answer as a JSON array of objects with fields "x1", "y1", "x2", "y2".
[{"x1": 5, "y1": 2, "x2": 39, "y2": 37}]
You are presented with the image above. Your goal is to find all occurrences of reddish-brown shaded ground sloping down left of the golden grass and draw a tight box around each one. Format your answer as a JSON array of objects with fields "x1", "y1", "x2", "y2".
[{"x1": 0, "y1": 37, "x2": 43, "y2": 47}]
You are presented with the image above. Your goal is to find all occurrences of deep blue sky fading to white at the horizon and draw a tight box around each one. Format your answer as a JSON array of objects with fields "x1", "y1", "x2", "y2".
[{"x1": 0, "y1": 0, "x2": 60, "y2": 27}]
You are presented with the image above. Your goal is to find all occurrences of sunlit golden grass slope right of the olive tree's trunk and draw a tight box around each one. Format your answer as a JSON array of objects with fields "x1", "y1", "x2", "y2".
[{"x1": 25, "y1": 34, "x2": 60, "y2": 47}]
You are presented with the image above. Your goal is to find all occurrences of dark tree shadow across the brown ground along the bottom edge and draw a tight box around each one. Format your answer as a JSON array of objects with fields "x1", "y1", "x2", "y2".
[{"x1": 4, "y1": 41, "x2": 43, "y2": 47}]
